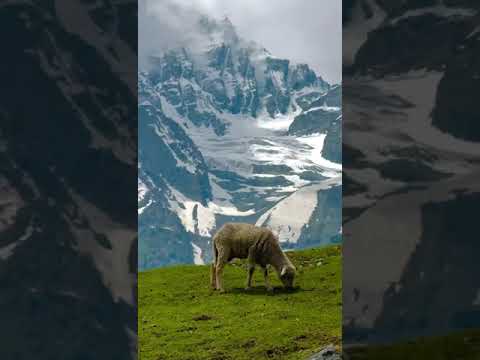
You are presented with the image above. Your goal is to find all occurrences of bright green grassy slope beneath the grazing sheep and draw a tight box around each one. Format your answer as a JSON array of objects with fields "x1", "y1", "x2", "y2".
[{"x1": 138, "y1": 246, "x2": 342, "y2": 360}]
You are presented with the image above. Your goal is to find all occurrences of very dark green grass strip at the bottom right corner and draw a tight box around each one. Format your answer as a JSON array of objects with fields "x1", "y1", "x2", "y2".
[{"x1": 346, "y1": 330, "x2": 480, "y2": 360}]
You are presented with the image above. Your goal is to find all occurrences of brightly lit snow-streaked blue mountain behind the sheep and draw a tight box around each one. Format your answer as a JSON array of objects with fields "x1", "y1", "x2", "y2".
[{"x1": 138, "y1": 16, "x2": 342, "y2": 268}]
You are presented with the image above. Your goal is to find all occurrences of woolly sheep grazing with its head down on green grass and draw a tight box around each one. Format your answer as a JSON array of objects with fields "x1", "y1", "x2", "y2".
[{"x1": 211, "y1": 223, "x2": 295, "y2": 292}]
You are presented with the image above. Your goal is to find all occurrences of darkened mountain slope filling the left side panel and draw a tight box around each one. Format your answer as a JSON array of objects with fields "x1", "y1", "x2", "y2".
[{"x1": 0, "y1": 1, "x2": 137, "y2": 359}]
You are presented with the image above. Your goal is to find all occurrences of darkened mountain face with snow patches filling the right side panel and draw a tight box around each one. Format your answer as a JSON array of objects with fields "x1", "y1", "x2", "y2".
[{"x1": 343, "y1": 1, "x2": 480, "y2": 344}]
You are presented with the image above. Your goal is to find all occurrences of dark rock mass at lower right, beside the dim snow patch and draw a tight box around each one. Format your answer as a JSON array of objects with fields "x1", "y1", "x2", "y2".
[{"x1": 376, "y1": 193, "x2": 480, "y2": 335}]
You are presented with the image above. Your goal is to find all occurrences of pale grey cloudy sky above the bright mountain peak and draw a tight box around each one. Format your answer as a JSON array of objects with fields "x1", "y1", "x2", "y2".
[{"x1": 139, "y1": 0, "x2": 342, "y2": 83}]
